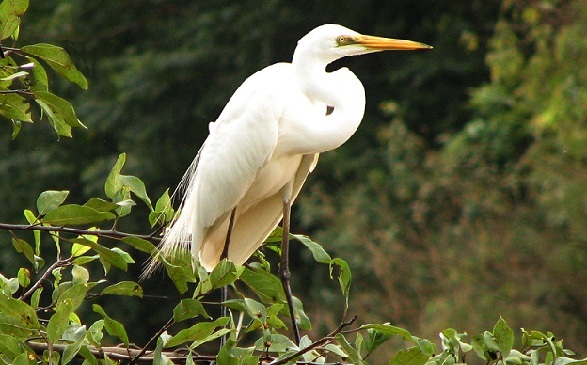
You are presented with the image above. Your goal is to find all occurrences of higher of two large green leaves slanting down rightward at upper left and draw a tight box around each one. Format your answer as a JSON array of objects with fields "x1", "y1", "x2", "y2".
[{"x1": 22, "y1": 43, "x2": 88, "y2": 90}]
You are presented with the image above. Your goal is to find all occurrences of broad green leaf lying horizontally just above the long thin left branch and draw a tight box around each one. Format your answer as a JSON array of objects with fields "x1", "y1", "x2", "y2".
[{"x1": 41, "y1": 204, "x2": 116, "y2": 226}]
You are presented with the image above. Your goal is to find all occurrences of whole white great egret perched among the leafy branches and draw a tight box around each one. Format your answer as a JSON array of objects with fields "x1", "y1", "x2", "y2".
[{"x1": 147, "y1": 24, "x2": 432, "y2": 342}]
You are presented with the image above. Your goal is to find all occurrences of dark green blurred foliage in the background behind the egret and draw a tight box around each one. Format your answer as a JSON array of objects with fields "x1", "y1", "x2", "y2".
[{"x1": 0, "y1": 0, "x2": 587, "y2": 356}]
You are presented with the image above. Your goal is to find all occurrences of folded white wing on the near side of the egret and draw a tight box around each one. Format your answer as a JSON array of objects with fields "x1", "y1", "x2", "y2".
[{"x1": 164, "y1": 65, "x2": 285, "y2": 264}]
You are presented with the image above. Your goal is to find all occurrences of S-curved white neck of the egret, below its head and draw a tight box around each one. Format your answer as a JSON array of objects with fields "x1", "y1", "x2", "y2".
[{"x1": 292, "y1": 49, "x2": 365, "y2": 153}]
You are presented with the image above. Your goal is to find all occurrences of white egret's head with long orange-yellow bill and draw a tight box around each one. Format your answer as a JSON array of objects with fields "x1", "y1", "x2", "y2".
[{"x1": 296, "y1": 24, "x2": 432, "y2": 63}]
